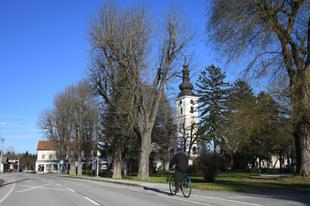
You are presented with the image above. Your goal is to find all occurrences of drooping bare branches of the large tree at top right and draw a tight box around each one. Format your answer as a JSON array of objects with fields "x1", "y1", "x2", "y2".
[{"x1": 207, "y1": 0, "x2": 309, "y2": 83}]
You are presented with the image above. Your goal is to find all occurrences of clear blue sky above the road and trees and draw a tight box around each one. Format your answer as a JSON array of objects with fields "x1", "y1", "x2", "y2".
[{"x1": 0, "y1": 0, "x2": 242, "y2": 153}]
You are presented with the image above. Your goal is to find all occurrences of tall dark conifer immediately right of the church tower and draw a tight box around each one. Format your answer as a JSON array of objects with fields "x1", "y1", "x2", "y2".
[{"x1": 196, "y1": 65, "x2": 229, "y2": 152}]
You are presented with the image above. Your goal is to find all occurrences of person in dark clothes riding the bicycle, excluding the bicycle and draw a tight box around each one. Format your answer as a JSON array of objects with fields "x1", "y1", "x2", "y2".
[{"x1": 169, "y1": 148, "x2": 188, "y2": 192}]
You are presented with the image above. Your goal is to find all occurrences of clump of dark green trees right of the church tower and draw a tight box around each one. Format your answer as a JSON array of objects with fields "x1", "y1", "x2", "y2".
[{"x1": 196, "y1": 65, "x2": 294, "y2": 170}]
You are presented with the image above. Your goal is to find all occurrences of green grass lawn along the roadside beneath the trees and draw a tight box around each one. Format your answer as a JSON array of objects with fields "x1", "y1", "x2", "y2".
[{"x1": 123, "y1": 172, "x2": 310, "y2": 193}]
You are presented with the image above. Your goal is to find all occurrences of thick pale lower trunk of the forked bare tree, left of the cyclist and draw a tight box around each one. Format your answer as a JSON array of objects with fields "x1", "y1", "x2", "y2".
[{"x1": 138, "y1": 129, "x2": 152, "y2": 180}]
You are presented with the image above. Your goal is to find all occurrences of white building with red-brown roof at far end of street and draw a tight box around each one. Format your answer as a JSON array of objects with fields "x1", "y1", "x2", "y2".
[{"x1": 35, "y1": 141, "x2": 59, "y2": 173}]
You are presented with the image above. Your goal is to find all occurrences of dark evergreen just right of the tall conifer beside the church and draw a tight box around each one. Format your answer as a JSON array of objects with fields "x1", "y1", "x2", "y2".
[{"x1": 221, "y1": 80, "x2": 257, "y2": 169}]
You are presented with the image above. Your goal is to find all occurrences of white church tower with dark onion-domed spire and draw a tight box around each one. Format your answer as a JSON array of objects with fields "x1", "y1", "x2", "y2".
[{"x1": 176, "y1": 61, "x2": 199, "y2": 164}]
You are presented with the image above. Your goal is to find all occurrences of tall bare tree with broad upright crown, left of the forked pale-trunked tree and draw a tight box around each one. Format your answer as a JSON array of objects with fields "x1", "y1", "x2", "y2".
[{"x1": 89, "y1": 4, "x2": 151, "y2": 178}]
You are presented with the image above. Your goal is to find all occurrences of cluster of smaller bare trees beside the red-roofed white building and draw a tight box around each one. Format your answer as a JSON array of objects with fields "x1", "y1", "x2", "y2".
[{"x1": 39, "y1": 81, "x2": 99, "y2": 174}]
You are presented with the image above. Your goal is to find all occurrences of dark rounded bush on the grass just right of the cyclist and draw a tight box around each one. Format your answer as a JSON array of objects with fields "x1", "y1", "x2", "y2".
[{"x1": 198, "y1": 153, "x2": 221, "y2": 182}]
